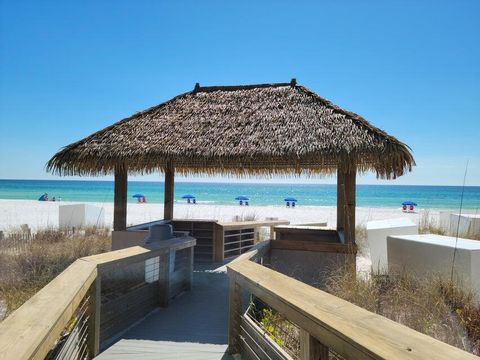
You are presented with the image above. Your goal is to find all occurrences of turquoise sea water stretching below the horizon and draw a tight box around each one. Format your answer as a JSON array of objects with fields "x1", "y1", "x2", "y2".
[{"x1": 0, "y1": 180, "x2": 480, "y2": 209}]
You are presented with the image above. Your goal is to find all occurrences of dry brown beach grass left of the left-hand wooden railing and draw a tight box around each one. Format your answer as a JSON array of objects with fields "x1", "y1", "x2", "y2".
[{"x1": 0, "y1": 227, "x2": 111, "y2": 320}]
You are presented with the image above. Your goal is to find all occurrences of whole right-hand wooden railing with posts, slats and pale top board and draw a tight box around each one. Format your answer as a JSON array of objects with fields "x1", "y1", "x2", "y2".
[{"x1": 227, "y1": 243, "x2": 478, "y2": 360}]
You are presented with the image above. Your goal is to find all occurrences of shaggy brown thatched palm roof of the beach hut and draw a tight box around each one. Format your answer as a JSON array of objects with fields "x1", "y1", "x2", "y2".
[{"x1": 47, "y1": 80, "x2": 414, "y2": 178}]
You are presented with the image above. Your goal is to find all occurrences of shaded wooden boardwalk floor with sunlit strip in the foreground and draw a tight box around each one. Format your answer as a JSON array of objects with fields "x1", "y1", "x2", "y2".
[{"x1": 96, "y1": 265, "x2": 233, "y2": 360}]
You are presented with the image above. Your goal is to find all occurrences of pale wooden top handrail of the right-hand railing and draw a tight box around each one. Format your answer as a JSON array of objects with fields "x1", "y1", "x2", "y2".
[{"x1": 227, "y1": 260, "x2": 478, "y2": 360}]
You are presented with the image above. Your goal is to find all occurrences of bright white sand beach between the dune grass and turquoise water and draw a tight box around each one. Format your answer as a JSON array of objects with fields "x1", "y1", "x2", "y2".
[{"x1": 0, "y1": 200, "x2": 439, "y2": 231}]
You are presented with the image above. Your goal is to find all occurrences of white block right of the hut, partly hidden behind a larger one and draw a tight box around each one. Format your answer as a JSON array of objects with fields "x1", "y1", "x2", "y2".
[{"x1": 367, "y1": 218, "x2": 418, "y2": 274}]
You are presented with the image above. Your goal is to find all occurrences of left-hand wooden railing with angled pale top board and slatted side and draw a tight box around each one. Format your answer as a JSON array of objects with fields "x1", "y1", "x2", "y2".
[{"x1": 0, "y1": 236, "x2": 195, "y2": 360}]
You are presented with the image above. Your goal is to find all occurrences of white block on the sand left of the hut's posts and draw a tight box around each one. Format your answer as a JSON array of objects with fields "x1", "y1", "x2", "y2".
[{"x1": 58, "y1": 204, "x2": 105, "y2": 227}]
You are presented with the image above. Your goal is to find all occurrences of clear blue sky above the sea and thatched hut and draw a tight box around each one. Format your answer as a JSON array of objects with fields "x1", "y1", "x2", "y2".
[{"x1": 0, "y1": 0, "x2": 480, "y2": 185}]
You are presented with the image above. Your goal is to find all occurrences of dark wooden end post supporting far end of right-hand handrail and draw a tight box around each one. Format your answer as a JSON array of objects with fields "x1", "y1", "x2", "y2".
[{"x1": 228, "y1": 274, "x2": 242, "y2": 354}]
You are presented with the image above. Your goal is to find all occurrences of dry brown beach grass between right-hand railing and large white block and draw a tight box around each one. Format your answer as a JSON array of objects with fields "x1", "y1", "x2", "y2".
[{"x1": 325, "y1": 268, "x2": 480, "y2": 355}]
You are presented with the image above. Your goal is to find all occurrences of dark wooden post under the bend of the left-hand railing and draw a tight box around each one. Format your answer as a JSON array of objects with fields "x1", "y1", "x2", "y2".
[{"x1": 88, "y1": 275, "x2": 102, "y2": 357}]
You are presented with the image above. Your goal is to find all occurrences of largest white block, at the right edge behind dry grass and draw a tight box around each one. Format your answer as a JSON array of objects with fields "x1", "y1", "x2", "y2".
[{"x1": 387, "y1": 234, "x2": 480, "y2": 297}]
